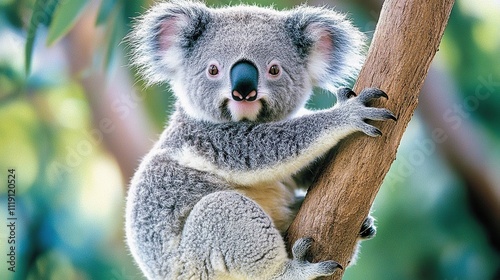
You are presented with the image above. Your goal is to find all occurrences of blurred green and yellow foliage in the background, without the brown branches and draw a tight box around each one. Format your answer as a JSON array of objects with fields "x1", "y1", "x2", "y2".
[{"x1": 0, "y1": 0, "x2": 500, "y2": 279}]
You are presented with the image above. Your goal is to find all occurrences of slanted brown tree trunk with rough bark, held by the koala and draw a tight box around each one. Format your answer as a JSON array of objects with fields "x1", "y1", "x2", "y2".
[{"x1": 287, "y1": 0, "x2": 454, "y2": 279}]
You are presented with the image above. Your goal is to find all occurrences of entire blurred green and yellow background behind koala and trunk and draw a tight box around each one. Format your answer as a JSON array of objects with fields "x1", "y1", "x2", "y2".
[{"x1": 0, "y1": 0, "x2": 500, "y2": 279}]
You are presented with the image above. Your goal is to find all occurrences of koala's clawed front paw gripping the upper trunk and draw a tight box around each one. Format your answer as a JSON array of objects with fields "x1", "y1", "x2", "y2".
[{"x1": 336, "y1": 88, "x2": 397, "y2": 137}]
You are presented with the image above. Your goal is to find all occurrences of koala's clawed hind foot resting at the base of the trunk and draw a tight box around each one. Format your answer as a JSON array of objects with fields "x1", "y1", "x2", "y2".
[{"x1": 283, "y1": 237, "x2": 343, "y2": 279}]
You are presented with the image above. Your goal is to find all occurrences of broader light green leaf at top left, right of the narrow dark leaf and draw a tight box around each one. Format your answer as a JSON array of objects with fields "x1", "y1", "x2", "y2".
[{"x1": 47, "y1": 0, "x2": 89, "y2": 46}]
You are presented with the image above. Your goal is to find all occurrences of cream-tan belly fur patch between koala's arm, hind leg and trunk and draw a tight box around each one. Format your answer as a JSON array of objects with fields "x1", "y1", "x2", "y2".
[{"x1": 235, "y1": 182, "x2": 295, "y2": 233}]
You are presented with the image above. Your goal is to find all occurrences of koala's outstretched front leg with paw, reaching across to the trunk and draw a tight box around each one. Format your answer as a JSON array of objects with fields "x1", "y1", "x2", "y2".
[{"x1": 172, "y1": 88, "x2": 396, "y2": 185}]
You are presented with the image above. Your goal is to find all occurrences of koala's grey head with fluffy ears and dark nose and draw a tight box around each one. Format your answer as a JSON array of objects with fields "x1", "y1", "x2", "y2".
[{"x1": 130, "y1": 1, "x2": 363, "y2": 122}]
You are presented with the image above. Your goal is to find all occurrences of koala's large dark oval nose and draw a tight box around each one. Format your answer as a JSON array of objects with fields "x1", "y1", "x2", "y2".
[{"x1": 230, "y1": 60, "x2": 259, "y2": 101}]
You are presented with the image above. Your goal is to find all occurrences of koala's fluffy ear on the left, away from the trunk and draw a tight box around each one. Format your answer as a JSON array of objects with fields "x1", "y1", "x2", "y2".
[{"x1": 127, "y1": 0, "x2": 211, "y2": 84}]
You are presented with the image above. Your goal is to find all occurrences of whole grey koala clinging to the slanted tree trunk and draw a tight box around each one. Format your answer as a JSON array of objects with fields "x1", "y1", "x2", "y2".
[{"x1": 125, "y1": 0, "x2": 395, "y2": 280}]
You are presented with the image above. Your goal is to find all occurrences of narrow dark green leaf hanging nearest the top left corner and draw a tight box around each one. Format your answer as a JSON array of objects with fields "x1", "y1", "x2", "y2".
[{"x1": 24, "y1": 0, "x2": 59, "y2": 74}]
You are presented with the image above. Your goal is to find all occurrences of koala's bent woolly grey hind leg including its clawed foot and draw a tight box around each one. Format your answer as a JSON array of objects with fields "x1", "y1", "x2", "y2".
[{"x1": 177, "y1": 191, "x2": 338, "y2": 280}]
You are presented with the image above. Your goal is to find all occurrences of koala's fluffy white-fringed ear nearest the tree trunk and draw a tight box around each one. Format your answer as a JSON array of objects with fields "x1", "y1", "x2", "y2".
[{"x1": 286, "y1": 6, "x2": 365, "y2": 91}]
